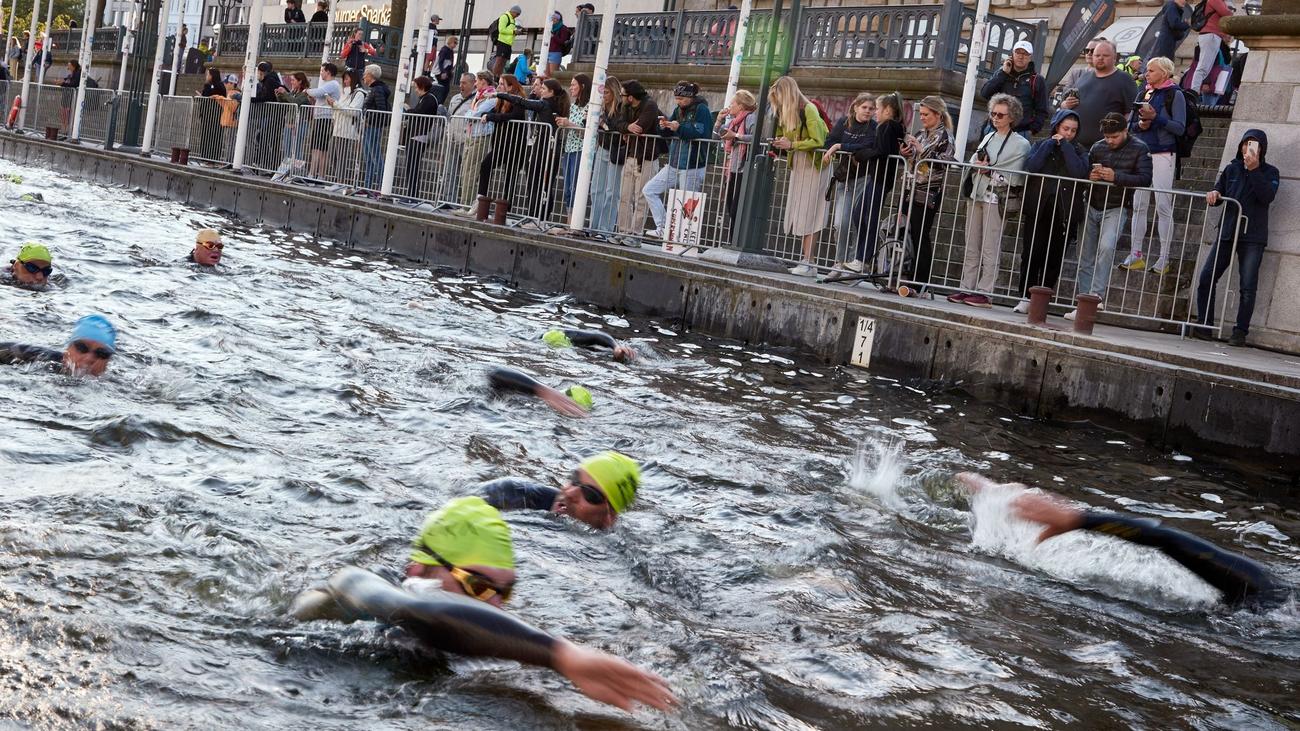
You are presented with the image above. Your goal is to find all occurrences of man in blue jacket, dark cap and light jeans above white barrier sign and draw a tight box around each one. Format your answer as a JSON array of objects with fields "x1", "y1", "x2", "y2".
[{"x1": 641, "y1": 81, "x2": 714, "y2": 238}]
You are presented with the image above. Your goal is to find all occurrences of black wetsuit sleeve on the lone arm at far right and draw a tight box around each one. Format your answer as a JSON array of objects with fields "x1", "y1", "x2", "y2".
[{"x1": 1082, "y1": 511, "x2": 1278, "y2": 604}]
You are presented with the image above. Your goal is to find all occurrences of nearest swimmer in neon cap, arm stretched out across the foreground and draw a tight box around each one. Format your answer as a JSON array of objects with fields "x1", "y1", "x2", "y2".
[{"x1": 289, "y1": 497, "x2": 677, "y2": 710}]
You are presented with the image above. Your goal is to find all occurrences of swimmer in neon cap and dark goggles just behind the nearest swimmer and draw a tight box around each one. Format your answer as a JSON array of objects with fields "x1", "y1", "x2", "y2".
[{"x1": 478, "y1": 451, "x2": 641, "y2": 531}]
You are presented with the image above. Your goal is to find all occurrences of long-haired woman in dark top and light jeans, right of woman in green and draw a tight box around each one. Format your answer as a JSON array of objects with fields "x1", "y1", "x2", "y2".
[{"x1": 822, "y1": 94, "x2": 876, "y2": 272}]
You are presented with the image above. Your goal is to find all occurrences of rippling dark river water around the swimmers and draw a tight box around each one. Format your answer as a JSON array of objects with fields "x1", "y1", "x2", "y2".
[{"x1": 0, "y1": 163, "x2": 1300, "y2": 730}]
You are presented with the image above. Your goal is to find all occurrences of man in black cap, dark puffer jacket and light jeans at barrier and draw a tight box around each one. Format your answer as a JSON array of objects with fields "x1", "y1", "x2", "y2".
[{"x1": 1065, "y1": 113, "x2": 1151, "y2": 320}]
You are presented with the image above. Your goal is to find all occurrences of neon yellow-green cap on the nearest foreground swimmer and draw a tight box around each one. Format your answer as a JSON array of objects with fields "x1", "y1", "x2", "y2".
[{"x1": 411, "y1": 497, "x2": 515, "y2": 568}]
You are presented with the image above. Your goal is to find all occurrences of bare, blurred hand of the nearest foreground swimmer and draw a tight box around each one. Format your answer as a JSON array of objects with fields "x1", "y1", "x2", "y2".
[{"x1": 551, "y1": 640, "x2": 677, "y2": 711}]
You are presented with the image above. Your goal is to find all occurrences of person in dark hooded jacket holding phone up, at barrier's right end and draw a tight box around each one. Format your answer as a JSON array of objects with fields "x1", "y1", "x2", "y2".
[{"x1": 1195, "y1": 130, "x2": 1279, "y2": 346}]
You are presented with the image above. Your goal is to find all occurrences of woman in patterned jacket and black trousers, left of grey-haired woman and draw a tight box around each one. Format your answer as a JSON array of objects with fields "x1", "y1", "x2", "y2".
[{"x1": 898, "y1": 96, "x2": 956, "y2": 297}]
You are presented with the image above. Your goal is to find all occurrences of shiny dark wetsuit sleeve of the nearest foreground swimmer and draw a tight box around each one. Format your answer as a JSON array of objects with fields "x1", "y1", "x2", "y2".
[{"x1": 329, "y1": 568, "x2": 555, "y2": 667}]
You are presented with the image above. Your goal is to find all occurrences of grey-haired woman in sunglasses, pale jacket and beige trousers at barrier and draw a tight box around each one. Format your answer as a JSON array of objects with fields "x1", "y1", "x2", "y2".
[{"x1": 948, "y1": 94, "x2": 1030, "y2": 307}]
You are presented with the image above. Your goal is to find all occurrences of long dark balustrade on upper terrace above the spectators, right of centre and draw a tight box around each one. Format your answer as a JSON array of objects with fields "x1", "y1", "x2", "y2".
[{"x1": 573, "y1": 0, "x2": 1047, "y2": 74}]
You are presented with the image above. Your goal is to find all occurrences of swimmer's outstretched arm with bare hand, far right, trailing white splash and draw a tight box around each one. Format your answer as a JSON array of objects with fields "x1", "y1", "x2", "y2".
[{"x1": 957, "y1": 472, "x2": 1290, "y2": 609}]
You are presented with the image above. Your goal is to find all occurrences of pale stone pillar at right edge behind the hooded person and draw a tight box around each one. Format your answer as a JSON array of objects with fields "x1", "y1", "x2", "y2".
[{"x1": 1206, "y1": 0, "x2": 1300, "y2": 352}]
